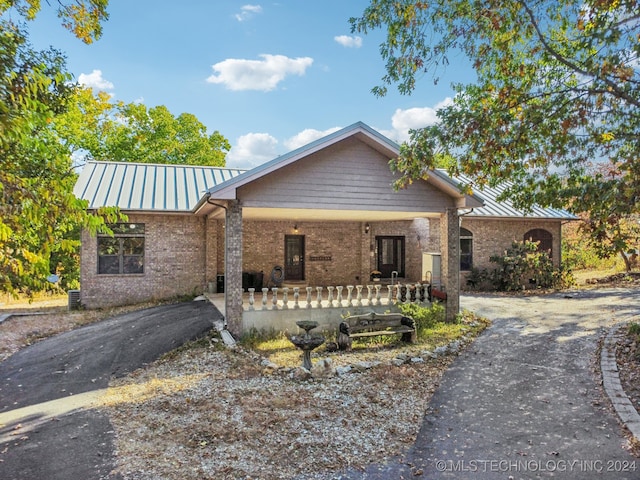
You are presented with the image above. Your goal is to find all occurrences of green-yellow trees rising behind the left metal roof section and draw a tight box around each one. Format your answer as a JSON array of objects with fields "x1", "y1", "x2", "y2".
[{"x1": 55, "y1": 88, "x2": 231, "y2": 166}]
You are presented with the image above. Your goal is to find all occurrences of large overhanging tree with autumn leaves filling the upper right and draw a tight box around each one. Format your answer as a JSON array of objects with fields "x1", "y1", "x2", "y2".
[{"x1": 350, "y1": 0, "x2": 640, "y2": 262}]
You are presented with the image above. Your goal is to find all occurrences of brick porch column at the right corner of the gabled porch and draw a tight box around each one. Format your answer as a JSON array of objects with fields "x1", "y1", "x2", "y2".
[{"x1": 440, "y1": 208, "x2": 460, "y2": 322}]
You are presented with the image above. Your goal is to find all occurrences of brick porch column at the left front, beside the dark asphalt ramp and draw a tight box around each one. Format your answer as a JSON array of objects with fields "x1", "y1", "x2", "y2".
[{"x1": 224, "y1": 200, "x2": 242, "y2": 338}]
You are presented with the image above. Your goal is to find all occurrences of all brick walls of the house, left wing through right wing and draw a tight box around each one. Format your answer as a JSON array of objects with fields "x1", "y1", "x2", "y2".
[{"x1": 81, "y1": 214, "x2": 561, "y2": 308}]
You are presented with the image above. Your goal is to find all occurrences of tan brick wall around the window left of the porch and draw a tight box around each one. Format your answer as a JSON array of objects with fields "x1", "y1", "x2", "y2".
[{"x1": 80, "y1": 214, "x2": 213, "y2": 308}]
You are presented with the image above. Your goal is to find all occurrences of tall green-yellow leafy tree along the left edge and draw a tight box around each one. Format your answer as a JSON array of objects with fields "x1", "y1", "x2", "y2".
[{"x1": 0, "y1": 0, "x2": 121, "y2": 293}]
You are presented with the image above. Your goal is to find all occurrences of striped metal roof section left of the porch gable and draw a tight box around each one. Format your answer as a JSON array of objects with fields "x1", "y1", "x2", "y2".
[{"x1": 73, "y1": 161, "x2": 244, "y2": 212}]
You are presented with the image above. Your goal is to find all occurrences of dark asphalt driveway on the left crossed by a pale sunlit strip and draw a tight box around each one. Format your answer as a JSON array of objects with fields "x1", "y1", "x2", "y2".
[{"x1": 0, "y1": 301, "x2": 221, "y2": 480}]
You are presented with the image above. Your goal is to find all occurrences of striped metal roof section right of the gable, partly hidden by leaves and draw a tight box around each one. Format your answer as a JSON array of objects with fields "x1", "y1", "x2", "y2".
[{"x1": 456, "y1": 171, "x2": 578, "y2": 220}]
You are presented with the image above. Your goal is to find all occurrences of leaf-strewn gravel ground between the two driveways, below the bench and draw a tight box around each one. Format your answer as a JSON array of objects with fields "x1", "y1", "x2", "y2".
[{"x1": 104, "y1": 330, "x2": 480, "y2": 480}]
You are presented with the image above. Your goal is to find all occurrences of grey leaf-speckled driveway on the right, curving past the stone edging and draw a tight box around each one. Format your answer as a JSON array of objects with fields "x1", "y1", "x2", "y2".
[{"x1": 330, "y1": 288, "x2": 640, "y2": 480}]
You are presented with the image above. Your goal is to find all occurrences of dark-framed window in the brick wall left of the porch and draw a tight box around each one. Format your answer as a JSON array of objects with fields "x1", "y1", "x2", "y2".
[{"x1": 98, "y1": 223, "x2": 144, "y2": 275}]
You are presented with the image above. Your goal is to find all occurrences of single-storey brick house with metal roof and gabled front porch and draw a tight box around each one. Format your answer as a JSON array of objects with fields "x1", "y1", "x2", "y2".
[{"x1": 75, "y1": 123, "x2": 573, "y2": 334}]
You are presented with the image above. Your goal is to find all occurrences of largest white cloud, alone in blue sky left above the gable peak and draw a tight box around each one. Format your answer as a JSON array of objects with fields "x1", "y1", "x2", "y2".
[{"x1": 207, "y1": 54, "x2": 313, "y2": 92}]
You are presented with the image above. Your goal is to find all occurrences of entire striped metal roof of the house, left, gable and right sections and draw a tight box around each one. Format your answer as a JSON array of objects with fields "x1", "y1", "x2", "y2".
[{"x1": 73, "y1": 122, "x2": 577, "y2": 220}]
